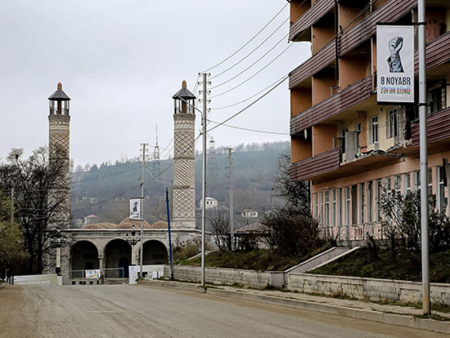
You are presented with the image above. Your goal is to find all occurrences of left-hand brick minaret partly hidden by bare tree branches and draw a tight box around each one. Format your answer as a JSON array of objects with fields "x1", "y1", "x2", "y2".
[{"x1": 48, "y1": 83, "x2": 70, "y2": 228}]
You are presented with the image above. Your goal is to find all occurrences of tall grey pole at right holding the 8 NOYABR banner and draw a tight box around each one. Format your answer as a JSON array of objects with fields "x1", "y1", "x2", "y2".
[{"x1": 418, "y1": 0, "x2": 431, "y2": 316}]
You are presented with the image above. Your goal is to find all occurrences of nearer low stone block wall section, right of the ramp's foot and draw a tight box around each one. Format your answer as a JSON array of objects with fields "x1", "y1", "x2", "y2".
[{"x1": 287, "y1": 273, "x2": 450, "y2": 305}]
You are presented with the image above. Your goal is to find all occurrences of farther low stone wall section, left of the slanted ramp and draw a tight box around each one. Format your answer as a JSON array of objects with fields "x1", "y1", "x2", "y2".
[{"x1": 164, "y1": 265, "x2": 283, "y2": 288}]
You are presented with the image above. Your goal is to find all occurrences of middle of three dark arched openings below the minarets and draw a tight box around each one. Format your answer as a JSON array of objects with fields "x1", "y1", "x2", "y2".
[{"x1": 103, "y1": 238, "x2": 131, "y2": 278}]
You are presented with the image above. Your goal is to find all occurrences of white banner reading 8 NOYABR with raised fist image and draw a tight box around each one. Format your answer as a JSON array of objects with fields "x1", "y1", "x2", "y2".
[{"x1": 377, "y1": 25, "x2": 414, "y2": 103}]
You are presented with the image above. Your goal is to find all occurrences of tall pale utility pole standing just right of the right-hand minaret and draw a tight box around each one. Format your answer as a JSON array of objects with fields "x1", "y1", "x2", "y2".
[{"x1": 202, "y1": 73, "x2": 208, "y2": 287}]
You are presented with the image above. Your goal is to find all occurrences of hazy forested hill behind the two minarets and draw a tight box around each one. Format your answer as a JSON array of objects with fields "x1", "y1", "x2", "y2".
[{"x1": 71, "y1": 142, "x2": 290, "y2": 224}]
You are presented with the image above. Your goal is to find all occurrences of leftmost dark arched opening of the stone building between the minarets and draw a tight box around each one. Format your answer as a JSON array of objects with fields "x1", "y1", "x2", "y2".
[{"x1": 70, "y1": 240, "x2": 100, "y2": 270}]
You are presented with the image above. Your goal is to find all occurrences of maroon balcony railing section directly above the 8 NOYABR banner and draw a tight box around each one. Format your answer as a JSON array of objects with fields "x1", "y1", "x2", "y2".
[{"x1": 338, "y1": 0, "x2": 417, "y2": 56}]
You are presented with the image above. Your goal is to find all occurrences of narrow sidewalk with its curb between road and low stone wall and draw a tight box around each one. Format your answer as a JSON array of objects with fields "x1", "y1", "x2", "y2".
[{"x1": 140, "y1": 280, "x2": 450, "y2": 333}]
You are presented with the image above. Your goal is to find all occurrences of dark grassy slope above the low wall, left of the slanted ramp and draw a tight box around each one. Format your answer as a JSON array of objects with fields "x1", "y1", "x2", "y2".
[{"x1": 177, "y1": 245, "x2": 331, "y2": 271}]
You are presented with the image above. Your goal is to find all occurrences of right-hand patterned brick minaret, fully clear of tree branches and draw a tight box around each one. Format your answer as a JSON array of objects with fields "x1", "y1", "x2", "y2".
[{"x1": 173, "y1": 81, "x2": 195, "y2": 229}]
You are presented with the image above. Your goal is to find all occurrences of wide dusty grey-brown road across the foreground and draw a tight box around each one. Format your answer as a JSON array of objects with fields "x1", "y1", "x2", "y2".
[{"x1": 0, "y1": 285, "x2": 447, "y2": 338}]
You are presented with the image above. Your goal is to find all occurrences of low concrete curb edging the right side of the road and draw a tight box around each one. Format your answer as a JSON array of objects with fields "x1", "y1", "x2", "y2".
[{"x1": 140, "y1": 281, "x2": 450, "y2": 333}]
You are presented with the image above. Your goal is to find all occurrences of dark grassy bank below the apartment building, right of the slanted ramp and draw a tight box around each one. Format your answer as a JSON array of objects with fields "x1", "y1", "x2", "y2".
[{"x1": 311, "y1": 248, "x2": 450, "y2": 283}]
